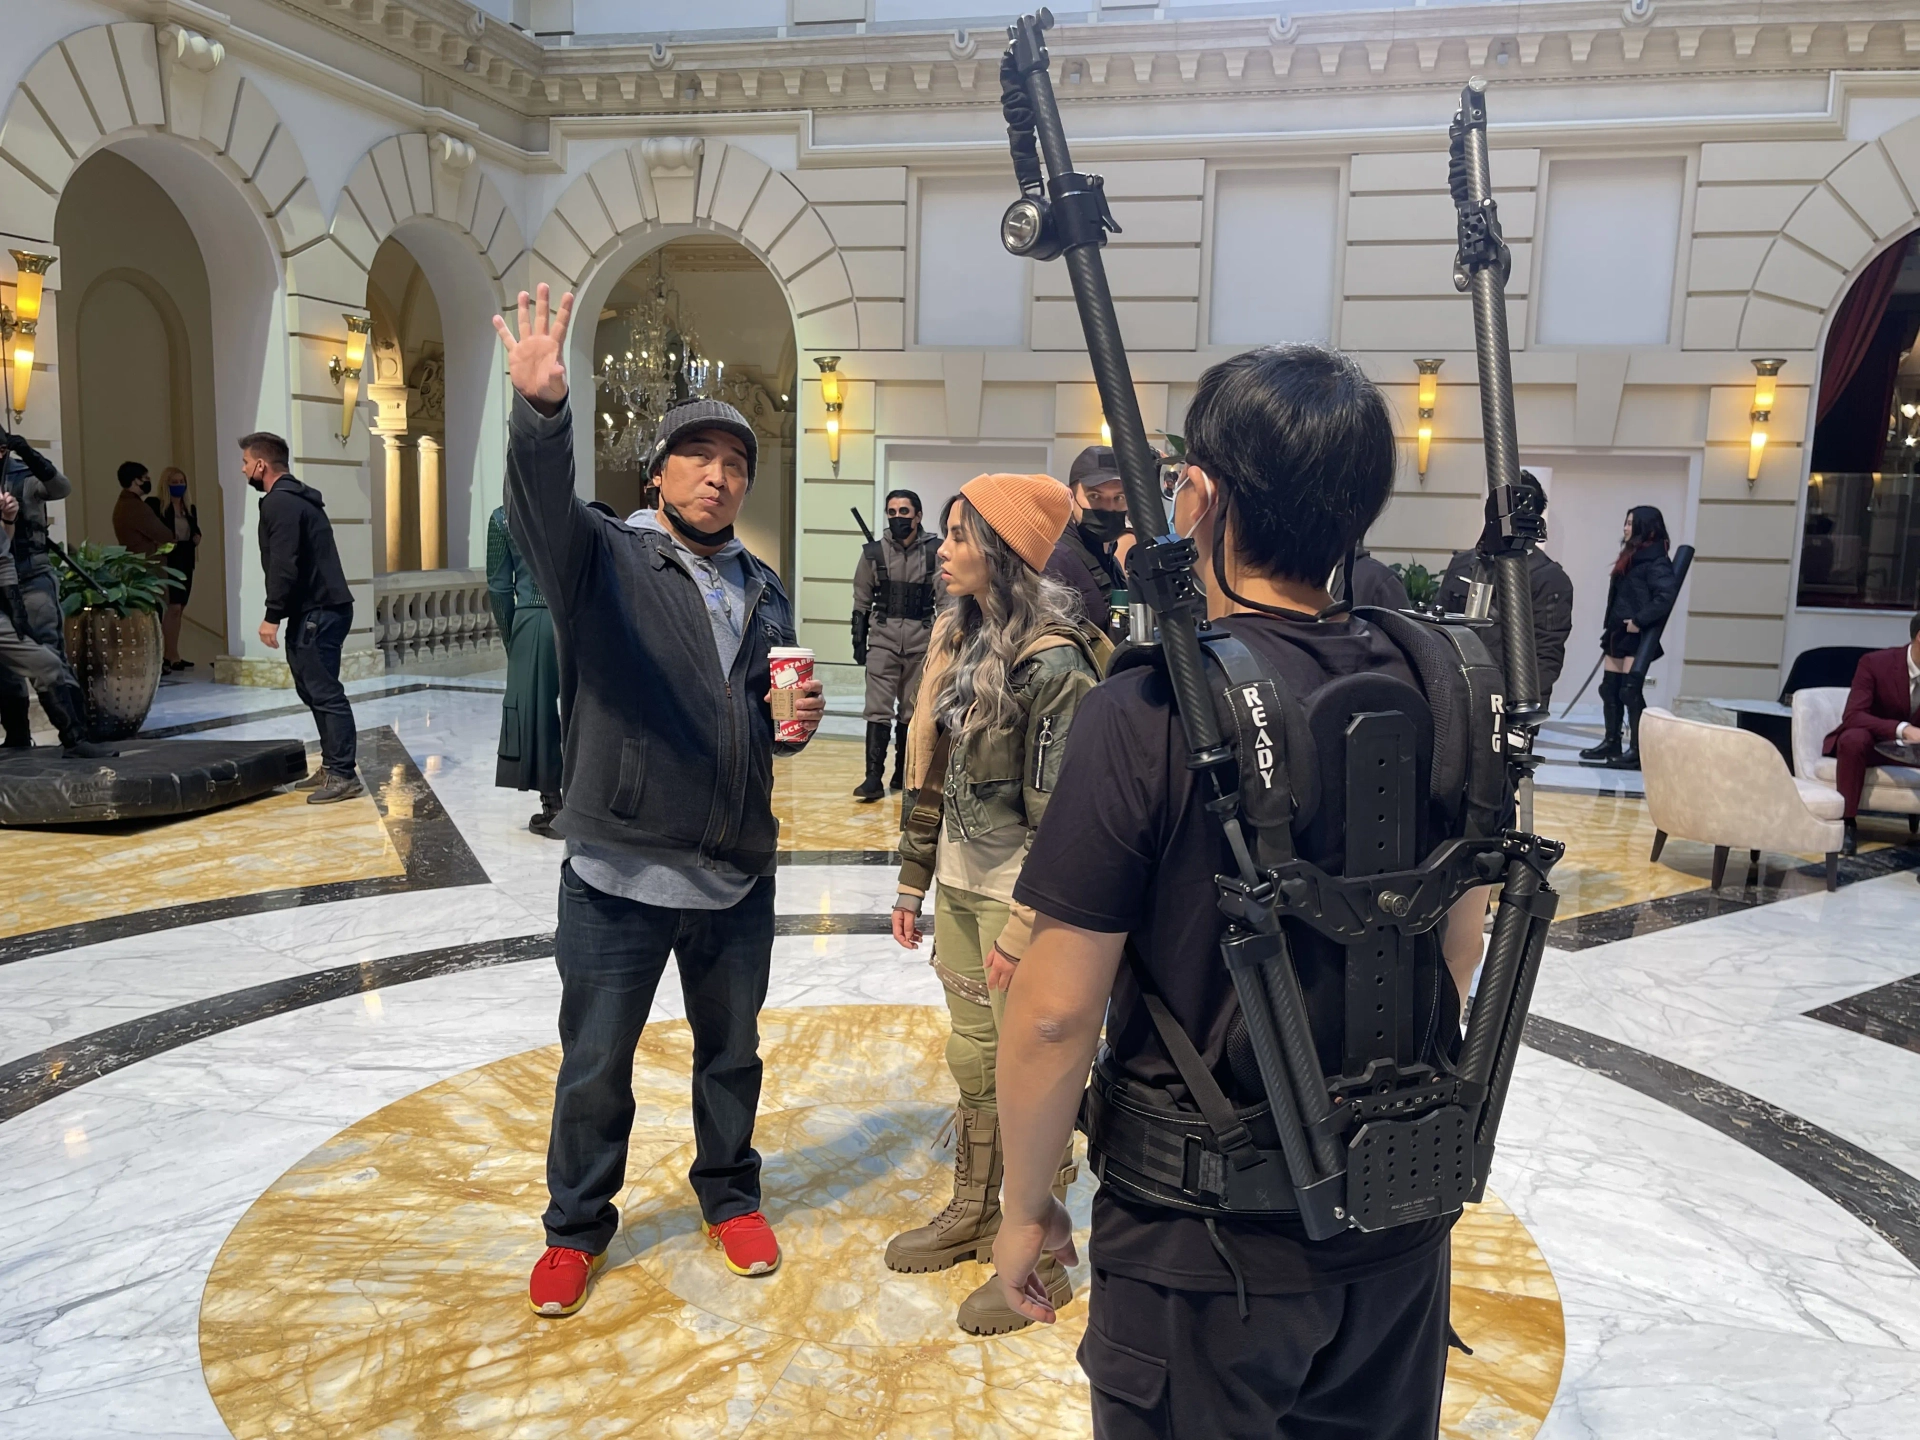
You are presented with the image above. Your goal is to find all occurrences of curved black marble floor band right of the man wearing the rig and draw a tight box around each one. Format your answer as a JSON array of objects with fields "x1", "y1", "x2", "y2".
[{"x1": 1526, "y1": 1016, "x2": 1920, "y2": 1267}]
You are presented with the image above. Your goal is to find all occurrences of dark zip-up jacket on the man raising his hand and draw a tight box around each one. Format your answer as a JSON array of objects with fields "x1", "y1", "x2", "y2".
[{"x1": 507, "y1": 396, "x2": 799, "y2": 876}]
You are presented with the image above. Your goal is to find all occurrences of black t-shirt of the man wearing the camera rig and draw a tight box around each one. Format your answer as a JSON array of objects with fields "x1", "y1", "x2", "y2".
[{"x1": 1014, "y1": 614, "x2": 1459, "y2": 1294}]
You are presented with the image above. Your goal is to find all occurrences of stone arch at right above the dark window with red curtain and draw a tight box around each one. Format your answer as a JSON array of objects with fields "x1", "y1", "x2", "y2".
[{"x1": 1738, "y1": 119, "x2": 1920, "y2": 353}]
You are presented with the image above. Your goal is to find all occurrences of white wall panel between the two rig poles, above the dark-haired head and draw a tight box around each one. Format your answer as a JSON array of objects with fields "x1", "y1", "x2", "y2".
[{"x1": 1208, "y1": 169, "x2": 1340, "y2": 346}]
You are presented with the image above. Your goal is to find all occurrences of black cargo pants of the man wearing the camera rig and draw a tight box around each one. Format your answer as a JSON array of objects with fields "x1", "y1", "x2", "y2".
[{"x1": 1079, "y1": 1242, "x2": 1452, "y2": 1440}]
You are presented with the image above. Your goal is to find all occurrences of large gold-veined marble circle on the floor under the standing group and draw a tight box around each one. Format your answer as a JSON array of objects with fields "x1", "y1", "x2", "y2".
[{"x1": 200, "y1": 1006, "x2": 1563, "y2": 1440}]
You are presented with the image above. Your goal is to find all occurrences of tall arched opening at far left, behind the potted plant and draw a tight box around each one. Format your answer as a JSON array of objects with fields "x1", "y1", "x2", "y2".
[{"x1": 54, "y1": 150, "x2": 228, "y2": 676}]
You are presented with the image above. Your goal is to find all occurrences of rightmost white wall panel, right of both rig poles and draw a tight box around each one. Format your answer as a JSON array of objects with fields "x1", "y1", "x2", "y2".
[{"x1": 1538, "y1": 157, "x2": 1686, "y2": 346}]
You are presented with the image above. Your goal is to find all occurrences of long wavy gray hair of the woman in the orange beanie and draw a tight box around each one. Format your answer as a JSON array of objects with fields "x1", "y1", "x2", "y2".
[{"x1": 933, "y1": 497, "x2": 1079, "y2": 735}]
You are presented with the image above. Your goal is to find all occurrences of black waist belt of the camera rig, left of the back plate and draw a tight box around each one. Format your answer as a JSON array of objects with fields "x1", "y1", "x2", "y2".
[{"x1": 1081, "y1": 1066, "x2": 1298, "y2": 1215}]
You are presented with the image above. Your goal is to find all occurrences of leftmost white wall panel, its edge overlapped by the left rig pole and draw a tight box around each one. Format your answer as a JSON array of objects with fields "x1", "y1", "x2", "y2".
[{"x1": 916, "y1": 175, "x2": 1029, "y2": 346}]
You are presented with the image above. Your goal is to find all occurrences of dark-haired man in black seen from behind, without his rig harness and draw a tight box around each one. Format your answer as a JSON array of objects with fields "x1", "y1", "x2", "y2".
[{"x1": 995, "y1": 346, "x2": 1486, "y2": 1440}]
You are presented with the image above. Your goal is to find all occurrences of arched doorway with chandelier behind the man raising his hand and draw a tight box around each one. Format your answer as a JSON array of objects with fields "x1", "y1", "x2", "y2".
[{"x1": 593, "y1": 234, "x2": 799, "y2": 586}]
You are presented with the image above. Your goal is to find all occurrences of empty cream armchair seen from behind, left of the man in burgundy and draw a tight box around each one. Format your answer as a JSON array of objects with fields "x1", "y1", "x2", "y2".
[{"x1": 1640, "y1": 710, "x2": 1845, "y2": 889}]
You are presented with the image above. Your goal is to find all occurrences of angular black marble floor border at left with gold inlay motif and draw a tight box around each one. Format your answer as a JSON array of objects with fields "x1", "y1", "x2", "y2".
[{"x1": 0, "y1": 733, "x2": 488, "y2": 966}]
